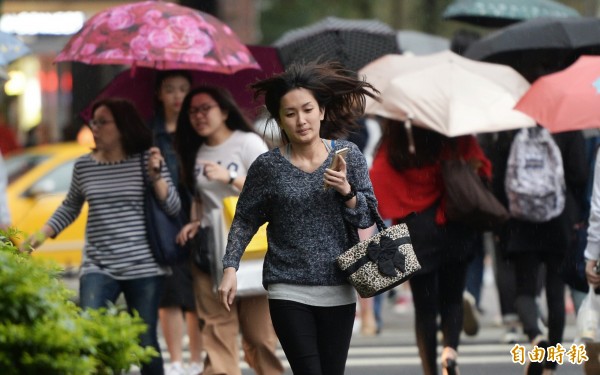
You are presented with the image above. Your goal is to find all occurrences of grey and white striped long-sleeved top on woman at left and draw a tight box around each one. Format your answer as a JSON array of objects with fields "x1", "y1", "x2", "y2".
[{"x1": 47, "y1": 153, "x2": 180, "y2": 280}]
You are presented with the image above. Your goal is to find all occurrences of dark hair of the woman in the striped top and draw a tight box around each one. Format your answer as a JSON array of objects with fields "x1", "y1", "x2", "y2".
[{"x1": 92, "y1": 98, "x2": 152, "y2": 156}]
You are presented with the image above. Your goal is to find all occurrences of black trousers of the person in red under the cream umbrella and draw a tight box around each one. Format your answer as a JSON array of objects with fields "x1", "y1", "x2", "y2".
[{"x1": 410, "y1": 261, "x2": 468, "y2": 375}]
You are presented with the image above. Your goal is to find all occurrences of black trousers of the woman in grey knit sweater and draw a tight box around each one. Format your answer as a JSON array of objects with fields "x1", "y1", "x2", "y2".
[{"x1": 269, "y1": 299, "x2": 356, "y2": 375}]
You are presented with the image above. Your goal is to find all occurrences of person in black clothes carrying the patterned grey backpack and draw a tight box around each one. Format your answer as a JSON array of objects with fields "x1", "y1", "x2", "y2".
[{"x1": 506, "y1": 131, "x2": 588, "y2": 374}]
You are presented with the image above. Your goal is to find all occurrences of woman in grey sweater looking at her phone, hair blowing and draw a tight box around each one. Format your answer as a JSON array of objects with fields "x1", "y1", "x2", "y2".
[{"x1": 219, "y1": 63, "x2": 377, "y2": 375}]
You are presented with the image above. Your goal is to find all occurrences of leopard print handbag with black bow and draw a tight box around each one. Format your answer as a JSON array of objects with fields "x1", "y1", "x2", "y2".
[{"x1": 337, "y1": 202, "x2": 421, "y2": 298}]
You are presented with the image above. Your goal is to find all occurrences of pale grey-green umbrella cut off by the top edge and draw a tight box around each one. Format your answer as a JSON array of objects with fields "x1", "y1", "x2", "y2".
[{"x1": 442, "y1": 0, "x2": 580, "y2": 27}]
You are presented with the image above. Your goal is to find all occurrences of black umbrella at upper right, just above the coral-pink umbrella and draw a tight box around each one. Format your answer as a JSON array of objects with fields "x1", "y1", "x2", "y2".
[{"x1": 465, "y1": 17, "x2": 600, "y2": 82}]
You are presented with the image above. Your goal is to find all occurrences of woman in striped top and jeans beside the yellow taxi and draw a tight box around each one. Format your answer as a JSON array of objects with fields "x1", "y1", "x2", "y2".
[{"x1": 21, "y1": 98, "x2": 180, "y2": 374}]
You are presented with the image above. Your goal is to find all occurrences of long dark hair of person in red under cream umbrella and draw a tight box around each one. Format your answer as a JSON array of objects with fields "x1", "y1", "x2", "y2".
[{"x1": 382, "y1": 119, "x2": 448, "y2": 171}]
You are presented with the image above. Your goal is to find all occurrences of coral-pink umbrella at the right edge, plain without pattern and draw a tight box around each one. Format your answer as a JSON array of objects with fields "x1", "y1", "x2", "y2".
[{"x1": 515, "y1": 56, "x2": 600, "y2": 133}]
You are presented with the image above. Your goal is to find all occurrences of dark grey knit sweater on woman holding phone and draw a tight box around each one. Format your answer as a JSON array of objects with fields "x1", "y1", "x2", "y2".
[{"x1": 223, "y1": 141, "x2": 377, "y2": 287}]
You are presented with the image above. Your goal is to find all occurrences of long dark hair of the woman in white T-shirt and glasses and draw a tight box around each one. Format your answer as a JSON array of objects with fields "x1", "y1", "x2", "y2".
[{"x1": 175, "y1": 86, "x2": 254, "y2": 191}]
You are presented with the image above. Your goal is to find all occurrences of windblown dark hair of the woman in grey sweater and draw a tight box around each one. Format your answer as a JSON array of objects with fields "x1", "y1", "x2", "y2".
[{"x1": 250, "y1": 62, "x2": 379, "y2": 143}]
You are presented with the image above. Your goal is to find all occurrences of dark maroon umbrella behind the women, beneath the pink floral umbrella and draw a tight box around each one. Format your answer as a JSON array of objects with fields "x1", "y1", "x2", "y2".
[{"x1": 81, "y1": 46, "x2": 283, "y2": 121}]
